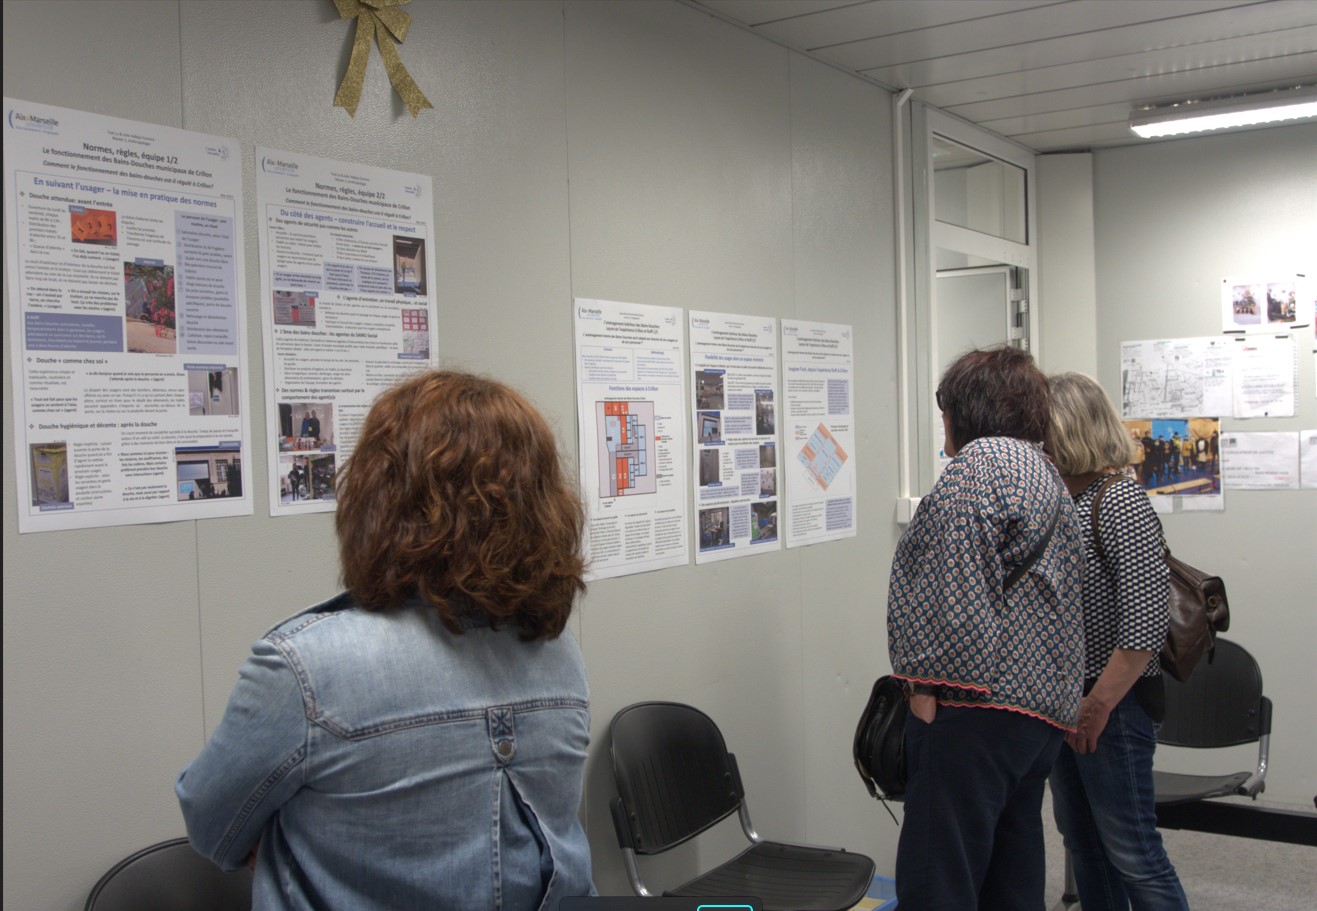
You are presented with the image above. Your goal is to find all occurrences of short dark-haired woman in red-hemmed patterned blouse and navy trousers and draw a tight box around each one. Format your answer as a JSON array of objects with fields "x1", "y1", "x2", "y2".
[{"x1": 888, "y1": 348, "x2": 1084, "y2": 911}]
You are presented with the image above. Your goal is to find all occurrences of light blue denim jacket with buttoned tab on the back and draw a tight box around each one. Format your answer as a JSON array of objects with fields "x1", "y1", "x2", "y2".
[{"x1": 175, "y1": 595, "x2": 595, "y2": 911}]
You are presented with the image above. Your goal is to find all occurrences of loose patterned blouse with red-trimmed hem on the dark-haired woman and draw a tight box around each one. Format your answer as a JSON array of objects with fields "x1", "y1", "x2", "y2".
[{"x1": 888, "y1": 437, "x2": 1084, "y2": 731}]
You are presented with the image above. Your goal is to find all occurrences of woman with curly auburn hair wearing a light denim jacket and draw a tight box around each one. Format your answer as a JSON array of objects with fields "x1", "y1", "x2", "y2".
[{"x1": 176, "y1": 371, "x2": 594, "y2": 911}]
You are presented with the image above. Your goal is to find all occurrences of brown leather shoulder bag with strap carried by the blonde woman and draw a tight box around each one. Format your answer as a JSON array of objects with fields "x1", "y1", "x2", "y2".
[{"x1": 1092, "y1": 474, "x2": 1230, "y2": 683}]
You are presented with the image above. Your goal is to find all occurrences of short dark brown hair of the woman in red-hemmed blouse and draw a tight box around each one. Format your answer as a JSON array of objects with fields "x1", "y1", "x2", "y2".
[{"x1": 938, "y1": 345, "x2": 1050, "y2": 449}]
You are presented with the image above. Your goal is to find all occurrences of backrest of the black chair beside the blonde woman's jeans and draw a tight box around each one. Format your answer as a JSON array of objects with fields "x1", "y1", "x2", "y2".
[{"x1": 1158, "y1": 636, "x2": 1271, "y2": 748}]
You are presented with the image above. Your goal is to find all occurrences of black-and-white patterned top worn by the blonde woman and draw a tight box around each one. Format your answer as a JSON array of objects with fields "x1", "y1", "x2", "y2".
[{"x1": 1075, "y1": 478, "x2": 1171, "y2": 679}]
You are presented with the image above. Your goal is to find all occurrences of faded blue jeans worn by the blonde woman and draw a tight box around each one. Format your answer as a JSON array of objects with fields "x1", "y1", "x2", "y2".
[{"x1": 1051, "y1": 692, "x2": 1189, "y2": 911}]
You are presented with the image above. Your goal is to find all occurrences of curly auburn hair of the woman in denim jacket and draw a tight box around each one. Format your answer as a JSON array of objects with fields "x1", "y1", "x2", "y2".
[{"x1": 335, "y1": 370, "x2": 585, "y2": 640}]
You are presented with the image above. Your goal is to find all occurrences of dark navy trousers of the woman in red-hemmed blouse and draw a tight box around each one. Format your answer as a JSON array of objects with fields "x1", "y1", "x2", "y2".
[{"x1": 897, "y1": 704, "x2": 1064, "y2": 911}]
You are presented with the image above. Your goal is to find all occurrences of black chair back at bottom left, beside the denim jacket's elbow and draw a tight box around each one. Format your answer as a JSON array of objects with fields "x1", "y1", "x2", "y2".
[{"x1": 83, "y1": 839, "x2": 252, "y2": 911}]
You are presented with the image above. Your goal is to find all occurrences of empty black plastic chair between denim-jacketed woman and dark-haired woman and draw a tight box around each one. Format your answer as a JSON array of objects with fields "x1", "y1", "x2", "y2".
[{"x1": 608, "y1": 702, "x2": 873, "y2": 911}]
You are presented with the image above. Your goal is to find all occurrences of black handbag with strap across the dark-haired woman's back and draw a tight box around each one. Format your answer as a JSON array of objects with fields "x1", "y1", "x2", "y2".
[{"x1": 851, "y1": 498, "x2": 1064, "y2": 819}]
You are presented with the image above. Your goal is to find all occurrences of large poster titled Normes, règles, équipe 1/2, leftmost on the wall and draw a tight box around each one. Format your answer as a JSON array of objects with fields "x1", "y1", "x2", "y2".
[{"x1": 4, "y1": 97, "x2": 252, "y2": 532}]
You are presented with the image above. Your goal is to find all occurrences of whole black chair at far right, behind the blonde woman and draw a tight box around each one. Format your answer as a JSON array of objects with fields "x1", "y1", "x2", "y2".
[{"x1": 1152, "y1": 637, "x2": 1271, "y2": 807}]
